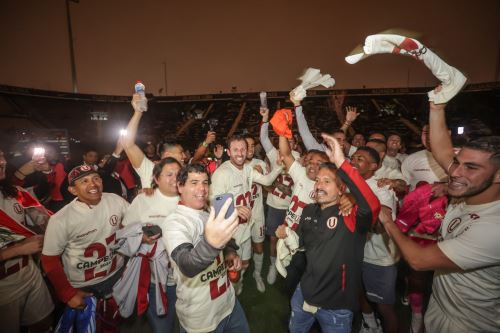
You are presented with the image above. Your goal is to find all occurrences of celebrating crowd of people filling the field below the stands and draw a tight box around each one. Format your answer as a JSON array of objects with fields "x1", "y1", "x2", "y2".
[{"x1": 0, "y1": 71, "x2": 500, "y2": 333}]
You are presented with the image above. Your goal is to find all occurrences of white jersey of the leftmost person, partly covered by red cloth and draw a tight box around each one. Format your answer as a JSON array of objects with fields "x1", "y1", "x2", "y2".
[{"x1": 0, "y1": 192, "x2": 39, "y2": 305}]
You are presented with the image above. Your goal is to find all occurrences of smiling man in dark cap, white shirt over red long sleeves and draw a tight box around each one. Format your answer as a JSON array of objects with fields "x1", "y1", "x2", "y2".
[{"x1": 42, "y1": 165, "x2": 129, "y2": 320}]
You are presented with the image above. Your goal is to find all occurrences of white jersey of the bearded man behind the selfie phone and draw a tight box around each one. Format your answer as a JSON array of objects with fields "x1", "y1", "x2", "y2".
[{"x1": 210, "y1": 161, "x2": 281, "y2": 245}]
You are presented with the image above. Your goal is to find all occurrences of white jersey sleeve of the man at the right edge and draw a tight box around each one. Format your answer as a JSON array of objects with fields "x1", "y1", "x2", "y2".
[{"x1": 437, "y1": 217, "x2": 500, "y2": 270}]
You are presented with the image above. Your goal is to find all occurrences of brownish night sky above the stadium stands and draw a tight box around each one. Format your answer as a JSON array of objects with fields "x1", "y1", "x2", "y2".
[{"x1": 0, "y1": 0, "x2": 500, "y2": 95}]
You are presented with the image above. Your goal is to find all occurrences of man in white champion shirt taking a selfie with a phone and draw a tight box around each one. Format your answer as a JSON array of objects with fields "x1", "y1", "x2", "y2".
[{"x1": 162, "y1": 164, "x2": 249, "y2": 333}]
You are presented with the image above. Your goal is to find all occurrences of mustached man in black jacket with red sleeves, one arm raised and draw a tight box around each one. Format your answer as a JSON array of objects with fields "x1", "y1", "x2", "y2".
[{"x1": 289, "y1": 134, "x2": 380, "y2": 333}]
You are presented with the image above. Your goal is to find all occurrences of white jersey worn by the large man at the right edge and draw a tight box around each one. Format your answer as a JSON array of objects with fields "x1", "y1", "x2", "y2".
[{"x1": 425, "y1": 201, "x2": 500, "y2": 332}]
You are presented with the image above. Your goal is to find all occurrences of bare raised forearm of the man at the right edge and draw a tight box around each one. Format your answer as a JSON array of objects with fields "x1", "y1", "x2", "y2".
[{"x1": 429, "y1": 102, "x2": 454, "y2": 172}]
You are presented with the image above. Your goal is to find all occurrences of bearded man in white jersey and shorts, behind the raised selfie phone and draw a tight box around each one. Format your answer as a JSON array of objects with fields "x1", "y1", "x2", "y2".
[{"x1": 210, "y1": 135, "x2": 282, "y2": 295}]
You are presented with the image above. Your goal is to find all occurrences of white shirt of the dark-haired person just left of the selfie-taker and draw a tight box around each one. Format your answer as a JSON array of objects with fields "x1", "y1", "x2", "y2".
[{"x1": 122, "y1": 188, "x2": 179, "y2": 286}]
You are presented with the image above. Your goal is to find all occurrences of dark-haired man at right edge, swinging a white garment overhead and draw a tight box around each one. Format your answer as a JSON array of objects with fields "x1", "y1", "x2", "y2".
[{"x1": 381, "y1": 97, "x2": 500, "y2": 333}]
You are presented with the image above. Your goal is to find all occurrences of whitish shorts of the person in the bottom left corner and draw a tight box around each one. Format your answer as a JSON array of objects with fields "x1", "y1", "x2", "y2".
[{"x1": 0, "y1": 268, "x2": 54, "y2": 332}]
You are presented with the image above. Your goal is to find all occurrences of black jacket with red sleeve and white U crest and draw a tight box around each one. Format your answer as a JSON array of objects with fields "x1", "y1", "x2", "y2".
[{"x1": 297, "y1": 161, "x2": 380, "y2": 311}]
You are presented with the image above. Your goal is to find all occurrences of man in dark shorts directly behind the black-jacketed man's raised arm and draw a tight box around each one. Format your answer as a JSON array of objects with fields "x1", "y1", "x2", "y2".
[{"x1": 351, "y1": 147, "x2": 399, "y2": 333}]
